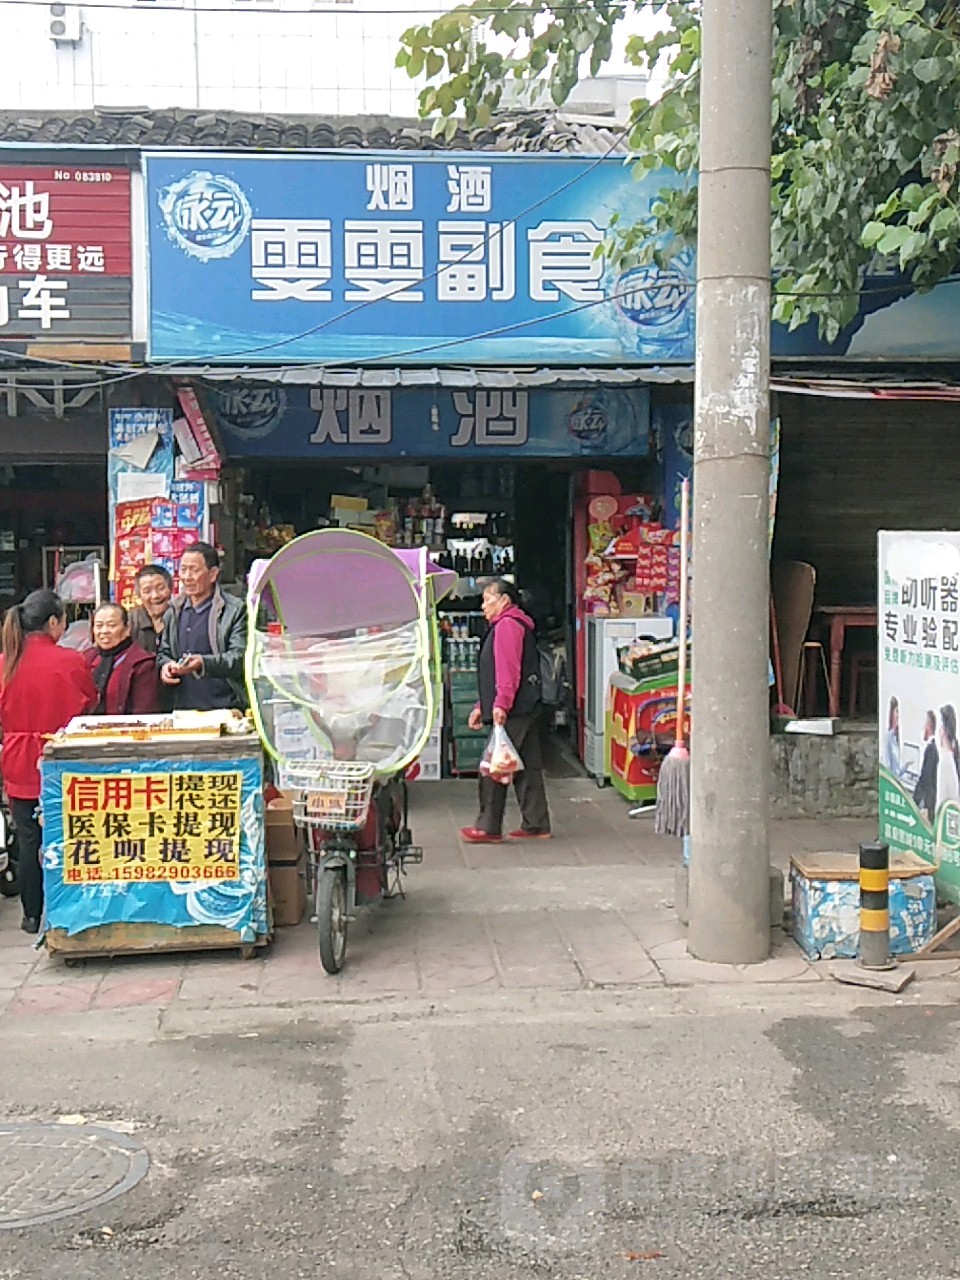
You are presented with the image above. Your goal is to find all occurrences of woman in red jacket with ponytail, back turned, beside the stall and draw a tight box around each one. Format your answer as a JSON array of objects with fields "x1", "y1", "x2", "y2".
[{"x1": 0, "y1": 591, "x2": 97, "y2": 933}]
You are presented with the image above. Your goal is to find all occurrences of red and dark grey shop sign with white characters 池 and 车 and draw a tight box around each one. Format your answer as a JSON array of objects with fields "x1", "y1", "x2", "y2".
[{"x1": 0, "y1": 164, "x2": 131, "y2": 339}]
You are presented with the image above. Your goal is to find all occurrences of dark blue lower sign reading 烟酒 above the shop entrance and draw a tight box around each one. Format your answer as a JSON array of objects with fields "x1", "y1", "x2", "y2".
[{"x1": 206, "y1": 384, "x2": 650, "y2": 461}]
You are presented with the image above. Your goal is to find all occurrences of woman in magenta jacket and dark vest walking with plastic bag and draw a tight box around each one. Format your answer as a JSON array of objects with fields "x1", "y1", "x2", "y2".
[{"x1": 460, "y1": 580, "x2": 550, "y2": 845}]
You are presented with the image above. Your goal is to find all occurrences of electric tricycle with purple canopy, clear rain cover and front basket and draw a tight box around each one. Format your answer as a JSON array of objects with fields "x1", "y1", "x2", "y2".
[{"x1": 247, "y1": 529, "x2": 456, "y2": 974}]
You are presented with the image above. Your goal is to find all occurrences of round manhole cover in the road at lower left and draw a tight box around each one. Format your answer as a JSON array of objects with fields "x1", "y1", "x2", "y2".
[{"x1": 0, "y1": 1123, "x2": 150, "y2": 1231}]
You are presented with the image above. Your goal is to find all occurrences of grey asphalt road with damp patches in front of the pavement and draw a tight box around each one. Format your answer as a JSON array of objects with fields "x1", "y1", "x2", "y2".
[{"x1": 0, "y1": 984, "x2": 960, "y2": 1280}]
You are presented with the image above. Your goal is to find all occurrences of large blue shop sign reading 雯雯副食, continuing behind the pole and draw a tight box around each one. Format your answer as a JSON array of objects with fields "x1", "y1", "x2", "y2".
[{"x1": 145, "y1": 151, "x2": 960, "y2": 365}]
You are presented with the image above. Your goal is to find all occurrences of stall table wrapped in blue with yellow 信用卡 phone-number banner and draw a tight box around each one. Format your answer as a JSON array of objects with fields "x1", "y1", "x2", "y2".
[{"x1": 41, "y1": 733, "x2": 270, "y2": 957}]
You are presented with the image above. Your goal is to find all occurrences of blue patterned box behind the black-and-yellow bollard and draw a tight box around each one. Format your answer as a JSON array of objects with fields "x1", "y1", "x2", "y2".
[{"x1": 790, "y1": 854, "x2": 937, "y2": 960}]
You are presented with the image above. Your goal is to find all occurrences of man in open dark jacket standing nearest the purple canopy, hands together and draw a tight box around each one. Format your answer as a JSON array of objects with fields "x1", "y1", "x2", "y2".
[{"x1": 156, "y1": 543, "x2": 247, "y2": 710}]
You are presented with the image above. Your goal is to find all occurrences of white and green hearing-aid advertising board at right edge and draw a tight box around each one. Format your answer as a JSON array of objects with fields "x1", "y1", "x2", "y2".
[{"x1": 878, "y1": 532, "x2": 960, "y2": 902}]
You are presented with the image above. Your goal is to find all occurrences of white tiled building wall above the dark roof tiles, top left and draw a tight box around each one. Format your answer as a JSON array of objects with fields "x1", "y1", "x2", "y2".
[{"x1": 0, "y1": 0, "x2": 419, "y2": 116}]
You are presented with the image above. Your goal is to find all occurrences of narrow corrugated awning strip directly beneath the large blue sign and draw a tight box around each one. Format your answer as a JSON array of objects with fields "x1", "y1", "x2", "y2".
[{"x1": 164, "y1": 365, "x2": 694, "y2": 389}]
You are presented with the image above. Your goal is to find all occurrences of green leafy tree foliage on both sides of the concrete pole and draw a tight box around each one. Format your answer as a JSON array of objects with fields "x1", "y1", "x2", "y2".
[{"x1": 397, "y1": 0, "x2": 960, "y2": 339}]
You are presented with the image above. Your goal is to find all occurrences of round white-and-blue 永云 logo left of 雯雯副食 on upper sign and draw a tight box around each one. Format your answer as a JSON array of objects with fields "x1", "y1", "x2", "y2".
[{"x1": 159, "y1": 172, "x2": 253, "y2": 262}]
